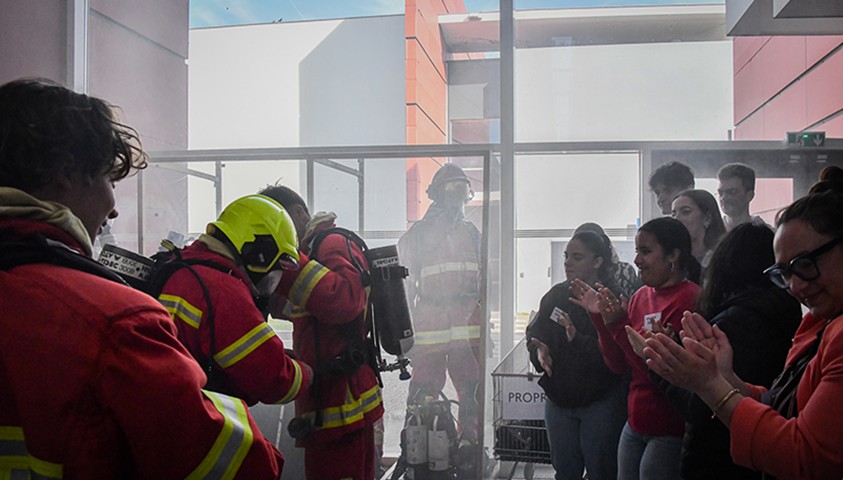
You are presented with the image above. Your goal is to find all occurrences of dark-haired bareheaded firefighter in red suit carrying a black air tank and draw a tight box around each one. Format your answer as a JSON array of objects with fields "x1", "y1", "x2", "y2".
[{"x1": 261, "y1": 185, "x2": 383, "y2": 480}]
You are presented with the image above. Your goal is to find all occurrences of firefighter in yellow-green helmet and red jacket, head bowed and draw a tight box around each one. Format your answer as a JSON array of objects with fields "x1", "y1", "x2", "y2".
[{"x1": 158, "y1": 195, "x2": 312, "y2": 405}]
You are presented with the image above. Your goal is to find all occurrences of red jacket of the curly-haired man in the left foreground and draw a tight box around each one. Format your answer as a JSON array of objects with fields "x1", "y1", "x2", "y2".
[{"x1": 0, "y1": 218, "x2": 283, "y2": 479}]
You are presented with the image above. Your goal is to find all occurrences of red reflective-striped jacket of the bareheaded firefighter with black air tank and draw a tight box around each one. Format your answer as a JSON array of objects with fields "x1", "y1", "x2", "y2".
[{"x1": 273, "y1": 233, "x2": 383, "y2": 446}]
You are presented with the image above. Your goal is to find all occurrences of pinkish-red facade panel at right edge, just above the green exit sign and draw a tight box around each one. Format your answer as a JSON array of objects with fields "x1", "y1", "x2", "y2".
[{"x1": 802, "y1": 50, "x2": 843, "y2": 126}]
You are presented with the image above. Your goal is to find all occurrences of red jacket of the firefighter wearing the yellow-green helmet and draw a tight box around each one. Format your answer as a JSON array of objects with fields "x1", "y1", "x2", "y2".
[{"x1": 158, "y1": 235, "x2": 311, "y2": 405}]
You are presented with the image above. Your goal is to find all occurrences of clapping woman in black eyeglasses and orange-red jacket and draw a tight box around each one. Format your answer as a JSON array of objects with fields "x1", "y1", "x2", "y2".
[{"x1": 644, "y1": 182, "x2": 843, "y2": 480}]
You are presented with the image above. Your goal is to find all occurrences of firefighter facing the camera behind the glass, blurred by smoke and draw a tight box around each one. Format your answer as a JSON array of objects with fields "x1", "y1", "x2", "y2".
[{"x1": 398, "y1": 163, "x2": 483, "y2": 470}]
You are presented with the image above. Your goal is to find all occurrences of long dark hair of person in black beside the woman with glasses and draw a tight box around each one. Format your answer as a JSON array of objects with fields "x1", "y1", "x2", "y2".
[{"x1": 697, "y1": 223, "x2": 776, "y2": 319}]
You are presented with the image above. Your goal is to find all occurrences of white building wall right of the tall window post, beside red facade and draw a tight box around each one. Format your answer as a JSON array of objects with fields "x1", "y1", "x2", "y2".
[{"x1": 515, "y1": 40, "x2": 733, "y2": 142}]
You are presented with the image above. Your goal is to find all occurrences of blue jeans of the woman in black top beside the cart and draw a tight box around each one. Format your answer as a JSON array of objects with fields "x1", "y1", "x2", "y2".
[{"x1": 544, "y1": 382, "x2": 627, "y2": 480}]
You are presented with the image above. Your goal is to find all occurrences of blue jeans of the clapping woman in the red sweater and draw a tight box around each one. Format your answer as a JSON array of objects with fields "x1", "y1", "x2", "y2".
[{"x1": 618, "y1": 423, "x2": 682, "y2": 480}]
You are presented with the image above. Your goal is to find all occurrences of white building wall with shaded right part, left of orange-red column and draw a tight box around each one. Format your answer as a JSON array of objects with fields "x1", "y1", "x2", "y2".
[{"x1": 189, "y1": 16, "x2": 406, "y2": 235}]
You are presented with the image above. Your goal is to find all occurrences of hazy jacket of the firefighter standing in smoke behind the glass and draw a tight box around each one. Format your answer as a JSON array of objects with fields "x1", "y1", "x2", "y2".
[{"x1": 398, "y1": 212, "x2": 482, "y2": 346}]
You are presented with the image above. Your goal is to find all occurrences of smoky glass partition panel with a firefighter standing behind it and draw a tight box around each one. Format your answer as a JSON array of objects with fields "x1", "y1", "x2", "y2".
[{"x1": 145, "y1": 147, "x2": 499, "y2": 478}]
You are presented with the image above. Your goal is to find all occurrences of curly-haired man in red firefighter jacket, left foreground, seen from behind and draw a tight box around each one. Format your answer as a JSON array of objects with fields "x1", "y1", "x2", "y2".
[{"x1": 0, "y1": 80, "x2": 283, "y2": 480}]
